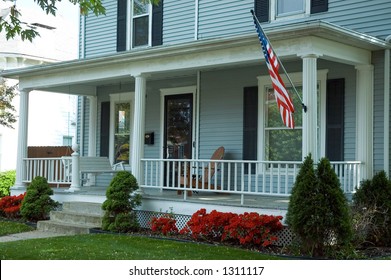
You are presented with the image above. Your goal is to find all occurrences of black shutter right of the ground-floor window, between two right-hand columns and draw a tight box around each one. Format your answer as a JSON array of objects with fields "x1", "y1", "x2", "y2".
[{"x1": 326, "y1": 79, "x2": 345, "y2": 161}]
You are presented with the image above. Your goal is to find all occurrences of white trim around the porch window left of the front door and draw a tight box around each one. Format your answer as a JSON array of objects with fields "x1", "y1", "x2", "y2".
[{"x1": 109, "y1": 92, "x2": 134, "y2": 166}]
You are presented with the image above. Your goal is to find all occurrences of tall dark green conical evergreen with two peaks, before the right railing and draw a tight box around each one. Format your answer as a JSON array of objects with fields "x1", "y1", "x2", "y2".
[{"x1": 286, "y1": 155, "x2": 352, "y2": 257}]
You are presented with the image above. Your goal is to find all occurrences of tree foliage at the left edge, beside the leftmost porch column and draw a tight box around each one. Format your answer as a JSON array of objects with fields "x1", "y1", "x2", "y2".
[{"x1": 0, "y1": 79, "x2": 18, "y2": 128}]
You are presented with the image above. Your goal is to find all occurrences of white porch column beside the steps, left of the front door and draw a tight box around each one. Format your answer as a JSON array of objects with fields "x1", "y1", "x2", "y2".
[{"x1": 131, "y1": 75, "x2": 146, "y2": 184}]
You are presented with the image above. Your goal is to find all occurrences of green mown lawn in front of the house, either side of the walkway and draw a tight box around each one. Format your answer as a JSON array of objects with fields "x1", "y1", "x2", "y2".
[{"x1": 0, "y1": 221, "x2": 278, "y2": 260}]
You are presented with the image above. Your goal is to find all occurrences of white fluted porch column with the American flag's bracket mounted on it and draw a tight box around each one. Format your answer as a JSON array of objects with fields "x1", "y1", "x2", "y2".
[{"x1": 304, "y1": 54, "x2": 319, "y2": 162}]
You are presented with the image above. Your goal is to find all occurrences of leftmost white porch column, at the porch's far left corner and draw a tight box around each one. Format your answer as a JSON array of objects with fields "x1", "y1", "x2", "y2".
[{"x1": 12, "y1": 89, "x2": 30, "y2": 189}]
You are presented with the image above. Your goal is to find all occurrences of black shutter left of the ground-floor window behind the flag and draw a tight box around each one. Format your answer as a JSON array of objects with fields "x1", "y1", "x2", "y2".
[{"x1": 243, "y1": 87, "x2": 258, "y2": 171}]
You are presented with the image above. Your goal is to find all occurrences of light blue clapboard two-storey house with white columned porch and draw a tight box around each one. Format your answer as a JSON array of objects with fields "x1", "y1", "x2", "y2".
[{"x1": 2, "y1": 0, "x2": 391, "y2": 218}]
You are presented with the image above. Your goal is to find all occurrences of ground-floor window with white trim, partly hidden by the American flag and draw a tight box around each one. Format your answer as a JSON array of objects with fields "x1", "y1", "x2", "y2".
[{"x1": 258, "y1": 70, "x2": 327, "y2": 161}]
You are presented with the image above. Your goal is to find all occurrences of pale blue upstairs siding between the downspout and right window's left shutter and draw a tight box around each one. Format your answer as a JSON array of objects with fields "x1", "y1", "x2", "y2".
[{"x1": 198, "y1": 0, "x2": 254, "y2": 39}]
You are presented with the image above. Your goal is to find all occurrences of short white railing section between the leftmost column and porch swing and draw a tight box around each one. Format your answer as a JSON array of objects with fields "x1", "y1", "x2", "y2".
[{"x1": 23, "y1": 157, "x2": 72, "y2": 187}]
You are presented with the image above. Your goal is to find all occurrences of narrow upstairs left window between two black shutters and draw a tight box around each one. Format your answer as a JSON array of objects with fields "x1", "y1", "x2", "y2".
[{"x1": 132, "y1": 0, "x2": 150, "y2": 47}]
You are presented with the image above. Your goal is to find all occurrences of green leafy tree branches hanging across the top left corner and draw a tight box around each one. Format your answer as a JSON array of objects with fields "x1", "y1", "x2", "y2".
[{"x1": 0, "y1": 0, "x2": 160, "y2": 41}]
